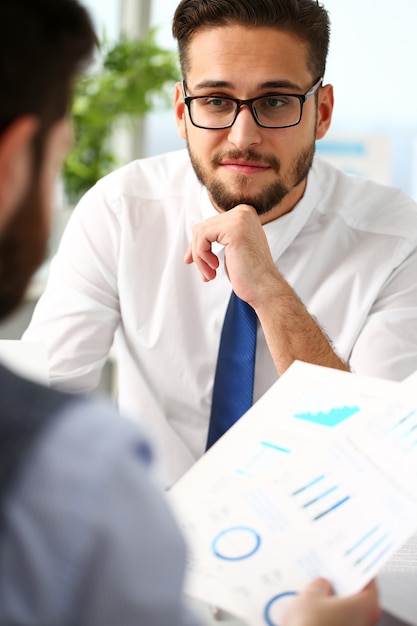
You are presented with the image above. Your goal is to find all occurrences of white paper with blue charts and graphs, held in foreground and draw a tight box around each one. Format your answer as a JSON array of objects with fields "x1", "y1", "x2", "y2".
[{"x1": 170, "y1": 363, "x2": 417, "y2": 626}]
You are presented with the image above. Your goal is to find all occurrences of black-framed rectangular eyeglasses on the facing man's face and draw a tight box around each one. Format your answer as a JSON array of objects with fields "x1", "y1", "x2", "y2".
[{"x1": 182, "y1": 77, "x2": 323, "y2": 130}]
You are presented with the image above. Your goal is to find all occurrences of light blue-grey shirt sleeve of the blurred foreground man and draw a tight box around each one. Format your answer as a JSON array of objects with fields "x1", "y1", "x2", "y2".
[{"x1": 0, "y1": 404, "x2": 197, "y2": 626}]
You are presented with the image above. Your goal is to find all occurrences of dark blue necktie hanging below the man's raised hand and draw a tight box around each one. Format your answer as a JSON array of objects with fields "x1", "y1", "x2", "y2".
[{"x1": 206, "y1": 292, "x2": 258, "y2": 449}]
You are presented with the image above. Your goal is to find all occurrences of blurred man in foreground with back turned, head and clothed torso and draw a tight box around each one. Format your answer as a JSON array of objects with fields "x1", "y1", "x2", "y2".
[{"x1": 0, "y1": 0, "x2": 197, "y2": 626}]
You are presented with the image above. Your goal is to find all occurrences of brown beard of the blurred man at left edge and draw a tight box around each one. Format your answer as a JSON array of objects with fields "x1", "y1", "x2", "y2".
[{"x1": 0, "y1": 178, "x2": 49, "y2": 318}]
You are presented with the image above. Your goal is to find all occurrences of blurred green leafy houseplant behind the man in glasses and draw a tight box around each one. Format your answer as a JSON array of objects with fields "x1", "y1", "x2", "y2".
[{"x1": 62, "y1": 29, "x2": 180, "y2": 203}]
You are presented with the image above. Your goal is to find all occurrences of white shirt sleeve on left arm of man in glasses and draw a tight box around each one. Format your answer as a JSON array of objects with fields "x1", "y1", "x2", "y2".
[{"x1": 22, "y1": 186, "x2": 120, "y2": 392}]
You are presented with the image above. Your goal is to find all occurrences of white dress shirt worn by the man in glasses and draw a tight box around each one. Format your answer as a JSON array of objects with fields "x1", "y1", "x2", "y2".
[{"x1": 24, "y1": 150, "x2": 417, "y2": 485}]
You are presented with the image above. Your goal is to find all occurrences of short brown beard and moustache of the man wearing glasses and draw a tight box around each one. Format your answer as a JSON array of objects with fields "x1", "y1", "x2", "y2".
[{"x1": 187, "y1": 141, "x2": 315, "y2": 215}]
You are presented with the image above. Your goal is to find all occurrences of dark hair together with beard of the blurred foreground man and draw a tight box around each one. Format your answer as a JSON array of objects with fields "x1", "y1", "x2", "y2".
[{"x1": 0, "y1": 0, "x2": 96, "y2": 318}]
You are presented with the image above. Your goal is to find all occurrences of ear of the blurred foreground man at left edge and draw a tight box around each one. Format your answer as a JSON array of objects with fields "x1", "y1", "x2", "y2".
[{"x1": 0, "y1": 115, "x2": 39, "y2": 227}]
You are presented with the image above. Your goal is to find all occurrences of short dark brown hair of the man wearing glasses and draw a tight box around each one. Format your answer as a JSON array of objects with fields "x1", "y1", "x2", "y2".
[{"x1": 172, "y1": 0, "x2": 330, "y2": 79}]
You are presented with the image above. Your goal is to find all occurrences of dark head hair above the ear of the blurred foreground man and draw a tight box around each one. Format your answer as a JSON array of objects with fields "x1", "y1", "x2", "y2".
[{"x1": 0, "y1": 0, "x2": 95, "y2": 139}]
